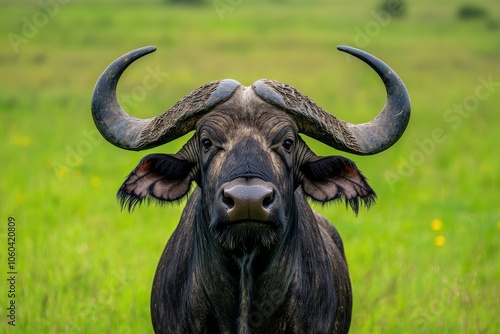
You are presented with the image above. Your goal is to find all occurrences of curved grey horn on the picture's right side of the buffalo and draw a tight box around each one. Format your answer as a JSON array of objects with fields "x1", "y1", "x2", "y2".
[{"x1": 252, "y1": 46, "x2": 411, "y2": 155}]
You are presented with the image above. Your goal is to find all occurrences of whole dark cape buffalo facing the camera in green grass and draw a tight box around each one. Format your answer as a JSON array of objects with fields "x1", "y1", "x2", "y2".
[{"x1": 92, "y1": 46, "x2": 410, "y2": 334}]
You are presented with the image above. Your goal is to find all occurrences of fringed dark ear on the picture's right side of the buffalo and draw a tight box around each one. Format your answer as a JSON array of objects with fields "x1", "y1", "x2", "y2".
[{"x1": 301, "y1": 156, "x2": 377, "y2": 214}]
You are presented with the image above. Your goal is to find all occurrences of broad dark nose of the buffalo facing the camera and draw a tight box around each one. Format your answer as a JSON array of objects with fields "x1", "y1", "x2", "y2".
[{"x1": 220, "y1": 183, "x2": 275, "y2": 221}]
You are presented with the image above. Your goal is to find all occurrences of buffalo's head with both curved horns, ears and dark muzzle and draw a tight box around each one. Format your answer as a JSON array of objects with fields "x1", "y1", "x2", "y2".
[{"x1": 92, "y1": 47, "x2": 410, "y2": 253}]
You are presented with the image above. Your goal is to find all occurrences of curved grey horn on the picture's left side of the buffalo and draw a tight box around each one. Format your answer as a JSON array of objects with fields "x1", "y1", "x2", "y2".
[{"x1": 92, "y1": 46, "x2": 241, "y2": 151}]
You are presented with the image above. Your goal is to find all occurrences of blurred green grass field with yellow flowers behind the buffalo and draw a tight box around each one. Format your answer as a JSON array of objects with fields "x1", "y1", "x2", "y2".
[{"x1": 0, "y1": 0, "x2": 500, "y2": 333}]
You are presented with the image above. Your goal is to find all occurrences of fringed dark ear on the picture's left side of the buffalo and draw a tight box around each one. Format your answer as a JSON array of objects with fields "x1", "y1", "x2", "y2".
[{"x1": 117, "y1": 154, "x2": 195, "y2": 211}]
